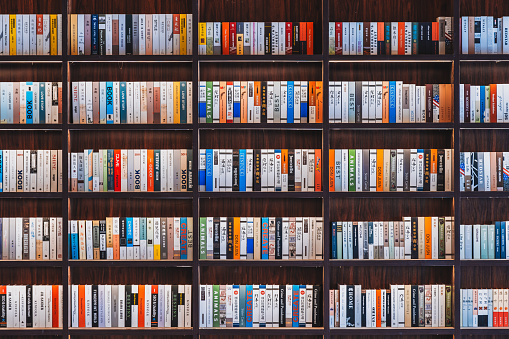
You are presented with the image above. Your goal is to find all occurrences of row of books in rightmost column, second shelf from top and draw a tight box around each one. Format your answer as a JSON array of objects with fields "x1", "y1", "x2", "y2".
[{"x1": 460, "y1": 84, "x2": 509, "y2": 123}]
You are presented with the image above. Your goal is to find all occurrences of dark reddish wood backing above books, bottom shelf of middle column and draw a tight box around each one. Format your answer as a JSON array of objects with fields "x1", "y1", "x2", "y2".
[{"x1": 200, "y1": 266, "x2": 323, "y2": 285}]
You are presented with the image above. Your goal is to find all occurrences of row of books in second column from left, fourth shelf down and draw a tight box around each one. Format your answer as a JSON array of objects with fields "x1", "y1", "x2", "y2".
[{"x1": 69, "y1": 217, "x2": 193, "y2": 260}]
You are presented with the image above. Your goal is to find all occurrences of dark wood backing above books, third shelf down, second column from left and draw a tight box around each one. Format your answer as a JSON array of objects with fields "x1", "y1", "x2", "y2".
[{"x1": 70, "y1": 130, "x2": 192, "y2": 152}]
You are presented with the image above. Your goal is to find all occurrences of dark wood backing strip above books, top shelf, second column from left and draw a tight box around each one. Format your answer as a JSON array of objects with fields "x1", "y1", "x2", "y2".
[{"x1": 68, "y1": 0, "x2": 193, "y2": 14}]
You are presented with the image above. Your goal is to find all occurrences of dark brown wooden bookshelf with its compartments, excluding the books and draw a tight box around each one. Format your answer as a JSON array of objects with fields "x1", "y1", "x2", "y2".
[{"x1": 0, "y1": 0, "x2": 509, "y2": 339}]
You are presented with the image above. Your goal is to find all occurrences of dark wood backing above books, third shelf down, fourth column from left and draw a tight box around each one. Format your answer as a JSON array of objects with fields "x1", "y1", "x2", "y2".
[{"x1": 330, "y1": 130, "x2": 454, "y2": 149}]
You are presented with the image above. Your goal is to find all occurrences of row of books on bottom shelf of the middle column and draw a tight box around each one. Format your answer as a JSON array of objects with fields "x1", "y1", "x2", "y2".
[{"x1": 199, "y1": 284, "x2": 322, "y2": 328}]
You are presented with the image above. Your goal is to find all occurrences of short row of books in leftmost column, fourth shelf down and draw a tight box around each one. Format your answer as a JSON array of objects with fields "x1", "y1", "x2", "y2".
[{"x1": 0, "y1": 217, "x2": 62, "y2": 260}]
